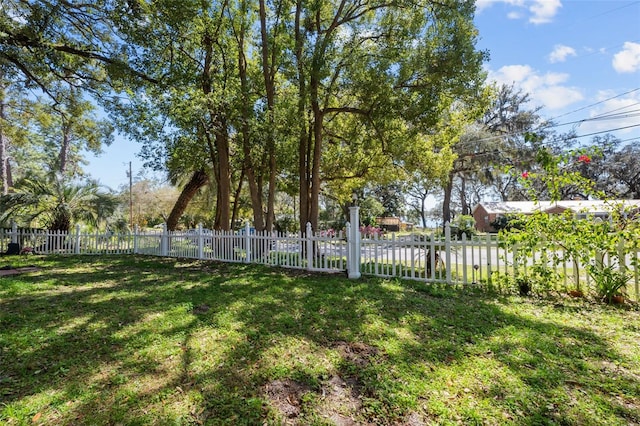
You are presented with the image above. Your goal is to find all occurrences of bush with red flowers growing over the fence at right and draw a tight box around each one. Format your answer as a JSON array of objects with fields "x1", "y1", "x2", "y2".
[{"x1": 500, "y1": 149, "x2": 640, "y2": 302}]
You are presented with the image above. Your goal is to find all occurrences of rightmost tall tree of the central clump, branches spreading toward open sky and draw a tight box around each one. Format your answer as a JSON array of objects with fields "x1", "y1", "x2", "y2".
[{"x1": 293, "y1": 0, "x2": 483, "y2": 228}]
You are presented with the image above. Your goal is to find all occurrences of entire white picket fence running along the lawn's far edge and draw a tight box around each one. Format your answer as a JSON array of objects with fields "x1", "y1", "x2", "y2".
[{"x1": 0, "y1": 208, "x2": 640, "y2": 301}]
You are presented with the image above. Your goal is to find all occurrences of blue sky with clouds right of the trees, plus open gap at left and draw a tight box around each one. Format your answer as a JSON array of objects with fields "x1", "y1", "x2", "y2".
[{"x1": 87, "y1": 0, "x2": 640, "y2": 189}]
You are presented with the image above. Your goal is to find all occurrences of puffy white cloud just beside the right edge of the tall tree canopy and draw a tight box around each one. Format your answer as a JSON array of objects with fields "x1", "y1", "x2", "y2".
[{"x1": 489, "y1": 65, "x2": 584, "y2": 110}]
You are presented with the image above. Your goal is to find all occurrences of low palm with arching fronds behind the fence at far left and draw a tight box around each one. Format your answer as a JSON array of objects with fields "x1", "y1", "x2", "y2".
[{"x1": 0, "y1": 173, "x2": 118, "y2": 231}]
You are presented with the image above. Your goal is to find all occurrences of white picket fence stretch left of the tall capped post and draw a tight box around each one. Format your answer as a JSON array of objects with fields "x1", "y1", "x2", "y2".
[{"x1": 0, "y1": 224, "x2": 347, "y2": 272}]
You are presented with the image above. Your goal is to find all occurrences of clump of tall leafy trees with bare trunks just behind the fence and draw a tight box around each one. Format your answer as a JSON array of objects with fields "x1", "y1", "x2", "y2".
[{"x1": 0, "y1": 0, "x2": 486, "y2": 229}]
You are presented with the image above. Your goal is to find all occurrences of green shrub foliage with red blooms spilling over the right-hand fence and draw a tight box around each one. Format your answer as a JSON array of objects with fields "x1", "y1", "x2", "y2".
[{"x1": 500, "y1": 149, "x2": 640, "y2": 299}]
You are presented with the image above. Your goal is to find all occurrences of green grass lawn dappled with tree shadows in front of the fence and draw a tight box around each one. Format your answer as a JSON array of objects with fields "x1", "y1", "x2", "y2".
[{"x1": 0, "y1": 256, "x2": 640, "y2": 425}]
